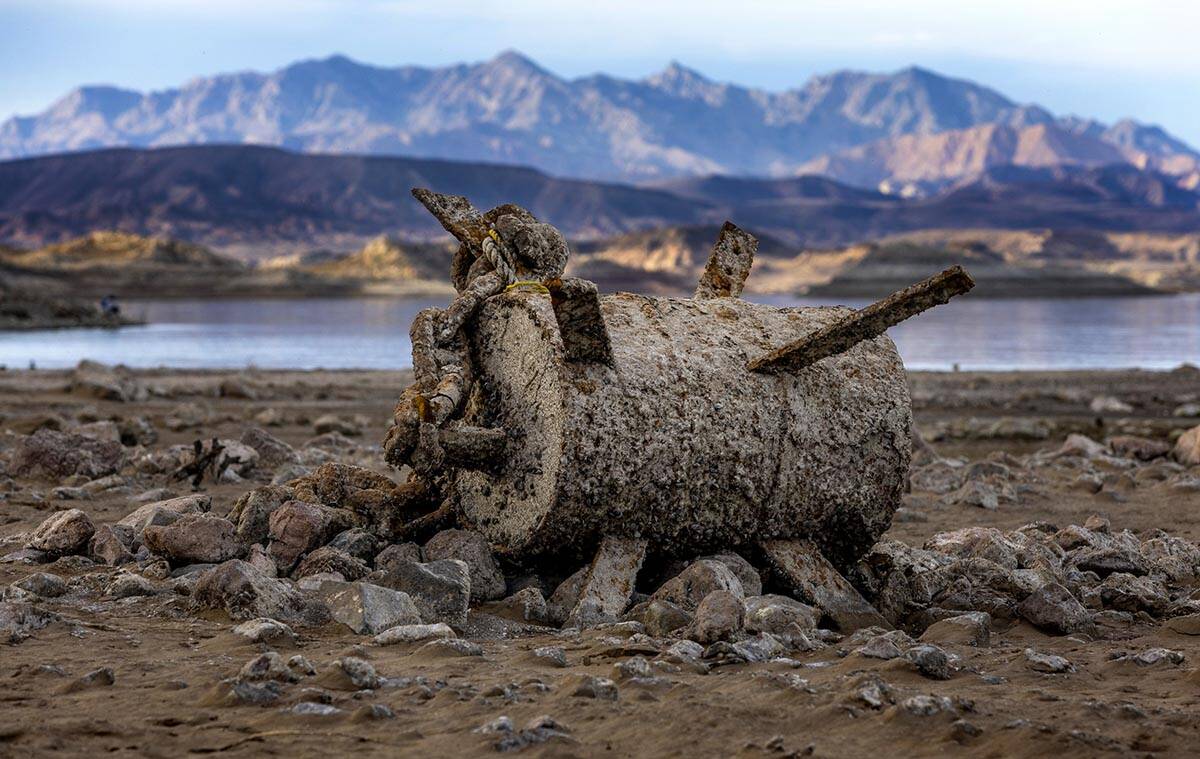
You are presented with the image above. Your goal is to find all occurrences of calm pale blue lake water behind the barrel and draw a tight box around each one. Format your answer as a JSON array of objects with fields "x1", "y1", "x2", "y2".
[{"x1": 0, "y1": 294, "x2": 1200, "y2": 370}]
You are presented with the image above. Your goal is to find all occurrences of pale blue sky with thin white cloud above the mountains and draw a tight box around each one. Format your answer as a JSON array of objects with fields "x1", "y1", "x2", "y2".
[{"x1": 0, "y1": 0, "x2": 1200, "y2": 147}]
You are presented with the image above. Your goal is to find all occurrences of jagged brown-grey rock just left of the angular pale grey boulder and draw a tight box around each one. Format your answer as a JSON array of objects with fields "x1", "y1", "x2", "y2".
[{"x1": 192, "y1": 560, "x2": 330, "y2": 626}]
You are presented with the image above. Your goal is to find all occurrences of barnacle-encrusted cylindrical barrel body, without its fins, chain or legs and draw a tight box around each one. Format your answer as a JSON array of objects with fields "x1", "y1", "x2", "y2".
[{"x1": 452, "y1": 292, "x2": 912, "y2": 564}]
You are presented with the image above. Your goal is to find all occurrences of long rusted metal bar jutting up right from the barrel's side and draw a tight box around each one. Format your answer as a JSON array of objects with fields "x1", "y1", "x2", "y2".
[{"x1": 746, "y1": 265, "x2": 974, "y2": 373}]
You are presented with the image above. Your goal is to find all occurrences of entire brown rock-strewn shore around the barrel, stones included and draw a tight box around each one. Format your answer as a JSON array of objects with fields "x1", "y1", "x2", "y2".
[{"x1": 0, "y1": 366, "x2": 1200, "y2": 757}]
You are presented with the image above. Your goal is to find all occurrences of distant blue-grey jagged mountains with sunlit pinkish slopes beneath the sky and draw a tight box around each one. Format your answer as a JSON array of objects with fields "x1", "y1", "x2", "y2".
[{"x1": 0, "y1": 52, "x2": 1200, "y2": 188}]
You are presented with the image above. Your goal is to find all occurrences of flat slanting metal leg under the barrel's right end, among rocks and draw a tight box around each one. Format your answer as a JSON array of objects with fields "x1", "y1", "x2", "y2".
[{"x1": 762, "y1": 540, "x2": 889, "y2": 633}]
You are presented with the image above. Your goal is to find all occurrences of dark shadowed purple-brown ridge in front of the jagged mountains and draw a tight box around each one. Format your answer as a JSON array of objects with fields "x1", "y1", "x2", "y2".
[{"x1": 0, "y1": 145, "x2": 1200, "y2": 259}]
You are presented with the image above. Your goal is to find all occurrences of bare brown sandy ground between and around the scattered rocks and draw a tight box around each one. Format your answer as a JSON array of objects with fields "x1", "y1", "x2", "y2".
[{"x1": 0, "y1": 369, "x2": 1200, "y2": 758}]
